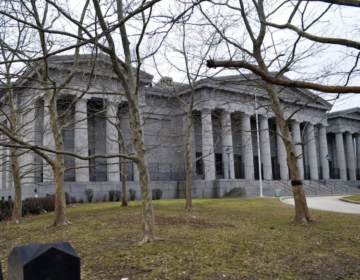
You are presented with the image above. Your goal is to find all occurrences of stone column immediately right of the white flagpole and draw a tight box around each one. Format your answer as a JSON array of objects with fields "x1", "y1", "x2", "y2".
[{"x1": 260, "y1": 117, "x2": 272, "y2": 180}]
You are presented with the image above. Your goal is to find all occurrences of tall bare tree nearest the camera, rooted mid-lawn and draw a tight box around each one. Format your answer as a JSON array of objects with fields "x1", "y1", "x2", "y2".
[{"x1": 88, "y1": 0, "x2": 165, "y2": 244}]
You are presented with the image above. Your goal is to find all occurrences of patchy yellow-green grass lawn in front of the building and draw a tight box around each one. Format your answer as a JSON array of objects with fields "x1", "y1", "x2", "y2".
[{"x1": 0, "y1": 198, "x2": 360, "y2": 280}]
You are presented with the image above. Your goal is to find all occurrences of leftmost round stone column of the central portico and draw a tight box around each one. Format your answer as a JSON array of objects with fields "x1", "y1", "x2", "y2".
[{"x1": 201, "y1": 108, "x2": 215, "y2": 180}]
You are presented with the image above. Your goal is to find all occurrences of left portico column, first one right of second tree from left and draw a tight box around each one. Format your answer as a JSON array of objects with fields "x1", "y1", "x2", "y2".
[{"x1": 74, "y1": 99, "x2": 89, "y2": 182}]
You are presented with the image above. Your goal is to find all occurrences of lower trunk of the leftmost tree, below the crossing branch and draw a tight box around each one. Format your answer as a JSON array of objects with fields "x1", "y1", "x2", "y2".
[{"x1": 11, "y1": 148, "x2": 22, "y2": 223}]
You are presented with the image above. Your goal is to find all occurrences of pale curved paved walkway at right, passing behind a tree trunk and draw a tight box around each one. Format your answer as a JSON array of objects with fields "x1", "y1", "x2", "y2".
[{"x1": 281, "y1": 195, "x2": 360, "y2": 214}]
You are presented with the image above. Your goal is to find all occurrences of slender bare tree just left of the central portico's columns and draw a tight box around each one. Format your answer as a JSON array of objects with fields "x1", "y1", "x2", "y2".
[{"x1": 160, "y1": 5, "x2": 221, "y2": 211}]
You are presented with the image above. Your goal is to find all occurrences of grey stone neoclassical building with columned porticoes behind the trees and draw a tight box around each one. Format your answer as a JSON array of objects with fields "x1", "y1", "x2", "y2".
[{"x1": 0, "y1": 56, "x2": 360, "y2": 198}]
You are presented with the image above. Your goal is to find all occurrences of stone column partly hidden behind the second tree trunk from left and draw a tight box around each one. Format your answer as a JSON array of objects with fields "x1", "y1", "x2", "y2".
[{"x1": 43, "y1": 96, "x2": 55, "y2": 182}]
